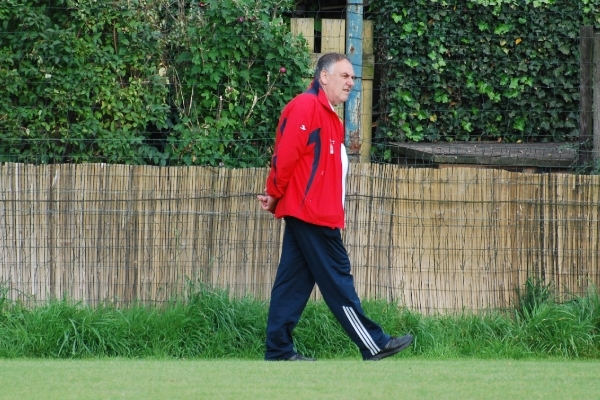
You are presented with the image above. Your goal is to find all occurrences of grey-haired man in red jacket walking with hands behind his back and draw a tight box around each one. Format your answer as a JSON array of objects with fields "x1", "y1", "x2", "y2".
[{"x1": 258, "y1": 53, "x2": 413, "y2": 361}]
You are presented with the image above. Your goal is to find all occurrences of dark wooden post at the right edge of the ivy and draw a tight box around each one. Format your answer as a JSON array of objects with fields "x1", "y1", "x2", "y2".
[{"x1": 579, "y1": 26, "x2": 594, "y2": 164}]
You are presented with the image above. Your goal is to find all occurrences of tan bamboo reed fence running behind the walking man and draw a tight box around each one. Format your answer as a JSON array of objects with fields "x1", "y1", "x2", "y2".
[{"x1": 0, "y1": 164, "x2": 600, "y2": 313}]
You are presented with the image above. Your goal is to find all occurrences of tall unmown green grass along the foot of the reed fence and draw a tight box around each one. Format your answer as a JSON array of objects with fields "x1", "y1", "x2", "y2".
[{"x1": 0, "y1": 281, "x2": 600, "y2": 359}]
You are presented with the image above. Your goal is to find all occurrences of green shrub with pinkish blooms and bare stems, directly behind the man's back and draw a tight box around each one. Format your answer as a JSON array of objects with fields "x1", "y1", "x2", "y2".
[{"x1": 167, "y1": 0, "x2": 310, "y2": 166}]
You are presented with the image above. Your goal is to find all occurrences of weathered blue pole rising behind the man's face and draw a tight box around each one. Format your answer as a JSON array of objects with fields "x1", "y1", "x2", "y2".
[{"x1": 344, "y1": 0, "x2": 363, "y2": 161}]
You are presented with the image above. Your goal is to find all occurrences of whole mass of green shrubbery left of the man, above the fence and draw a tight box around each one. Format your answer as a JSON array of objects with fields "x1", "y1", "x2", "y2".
[{"x1": 0, "y1": 0, "x2": 309, "y2": 166}]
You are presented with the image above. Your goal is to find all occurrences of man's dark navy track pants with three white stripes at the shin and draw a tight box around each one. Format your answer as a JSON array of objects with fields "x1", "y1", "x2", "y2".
[{"x1": 265, "y1": 217, "x2": 390, "y2": 360}]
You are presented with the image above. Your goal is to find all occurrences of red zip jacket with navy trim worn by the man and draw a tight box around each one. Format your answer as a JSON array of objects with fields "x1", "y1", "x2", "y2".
[{"x1": 267, "y1": 81, "x2": 344, "y2": 228}]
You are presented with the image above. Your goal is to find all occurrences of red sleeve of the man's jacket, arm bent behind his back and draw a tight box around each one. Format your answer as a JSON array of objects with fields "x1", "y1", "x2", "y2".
[{"x1": 266, "y1": 101, "x2": 315, "y2": 199}]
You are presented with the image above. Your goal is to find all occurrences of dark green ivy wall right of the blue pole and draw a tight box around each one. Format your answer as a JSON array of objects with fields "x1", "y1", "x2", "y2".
[{"x1": 371, "y1": 0, "x2": 600, "y2": 160}]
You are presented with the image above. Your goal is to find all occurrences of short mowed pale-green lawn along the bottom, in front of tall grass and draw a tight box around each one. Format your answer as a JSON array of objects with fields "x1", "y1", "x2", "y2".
[{"x1": 0, "y1": 357, "x2": 600, "y2": 400}]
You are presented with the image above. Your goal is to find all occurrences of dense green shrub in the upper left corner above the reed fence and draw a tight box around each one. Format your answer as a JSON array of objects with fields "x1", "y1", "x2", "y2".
[{"x1": 0, "y1": 0, "x2": 168, "y2": 164}]
